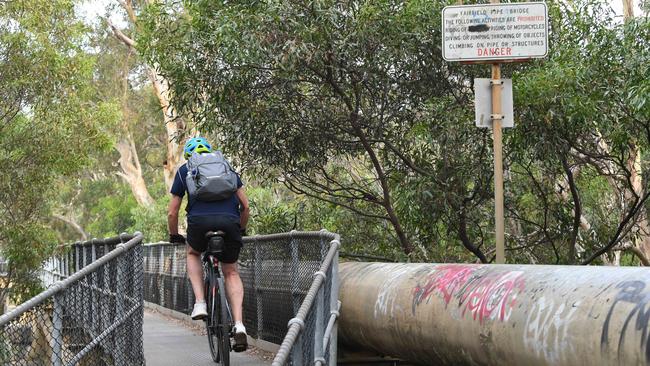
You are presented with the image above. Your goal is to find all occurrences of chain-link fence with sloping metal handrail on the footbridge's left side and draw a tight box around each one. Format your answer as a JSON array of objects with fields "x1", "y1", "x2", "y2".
[{"x1": 0, "y1": 233, "x2": 144, "y2": 366}]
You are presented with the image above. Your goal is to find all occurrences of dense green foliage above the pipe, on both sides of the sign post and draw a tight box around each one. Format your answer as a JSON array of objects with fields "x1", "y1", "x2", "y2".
[{"x1": 139, "y1": 0, "x2": 650, "y2": 263}]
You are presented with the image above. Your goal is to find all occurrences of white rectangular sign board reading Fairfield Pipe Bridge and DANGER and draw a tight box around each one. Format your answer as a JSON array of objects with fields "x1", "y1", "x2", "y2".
[{"x1": 442, "y1": 2, "x2": 548, "y2": 62}]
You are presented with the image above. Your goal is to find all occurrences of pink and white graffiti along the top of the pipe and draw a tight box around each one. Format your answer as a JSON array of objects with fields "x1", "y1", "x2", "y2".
[{"x1": 412, "y1": 264, "x2": 525, "y2": 324}]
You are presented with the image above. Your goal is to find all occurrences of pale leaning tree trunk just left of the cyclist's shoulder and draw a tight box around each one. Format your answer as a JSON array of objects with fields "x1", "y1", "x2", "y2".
[{"x1": 115, "y1": 136, "x2": 154, "y2": 208}]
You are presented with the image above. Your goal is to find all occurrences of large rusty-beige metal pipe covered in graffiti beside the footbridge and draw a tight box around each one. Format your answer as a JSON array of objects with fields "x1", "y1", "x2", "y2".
[{"x1": 339, "y1": 263, "x2": 650, "y2": 366}]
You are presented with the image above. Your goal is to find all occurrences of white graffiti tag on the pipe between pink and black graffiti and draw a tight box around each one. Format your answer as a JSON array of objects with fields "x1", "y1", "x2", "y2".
[{"x1": 524, "y1": 297, "x2": 580, "y2": 364}]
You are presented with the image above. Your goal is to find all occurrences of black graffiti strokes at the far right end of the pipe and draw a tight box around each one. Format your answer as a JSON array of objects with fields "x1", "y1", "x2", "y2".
[{"x1": 600, "y1": 281, "x2": 650, "y2": 363}]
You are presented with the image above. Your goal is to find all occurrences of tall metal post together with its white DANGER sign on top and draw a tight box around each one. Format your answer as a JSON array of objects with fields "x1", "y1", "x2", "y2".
[{"x1": 442, "y1": 0, "x2": 548, "y2": 263}]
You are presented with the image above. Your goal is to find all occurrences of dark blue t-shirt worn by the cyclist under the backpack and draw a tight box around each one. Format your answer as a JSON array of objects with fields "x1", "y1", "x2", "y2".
[{"x1": 171, "y1": 164, "x2": 243, "y2": 219}]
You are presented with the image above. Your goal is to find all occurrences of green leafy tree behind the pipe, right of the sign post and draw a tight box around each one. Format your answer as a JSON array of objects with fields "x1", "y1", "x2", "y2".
[{"x1": 510, "y1": 2, "x2": 650, "y2": 264}]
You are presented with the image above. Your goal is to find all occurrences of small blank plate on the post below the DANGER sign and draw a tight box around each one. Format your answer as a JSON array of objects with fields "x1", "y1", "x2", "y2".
[{"x1": 474, "y1": 78, "x2": 515, "y2": 128}]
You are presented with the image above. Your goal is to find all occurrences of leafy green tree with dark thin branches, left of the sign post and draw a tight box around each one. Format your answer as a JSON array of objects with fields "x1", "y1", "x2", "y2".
[{"x1": 143, "y1": 2, "x2": 486, "y2": 254}]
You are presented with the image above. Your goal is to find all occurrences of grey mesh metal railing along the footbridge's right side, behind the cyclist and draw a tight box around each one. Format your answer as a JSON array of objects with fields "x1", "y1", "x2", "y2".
[{"x1": 144, "y1": 230, "x2": 340, "y2": 366}]
